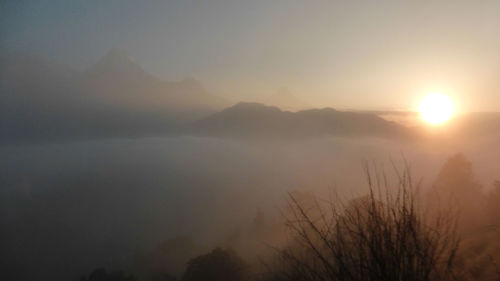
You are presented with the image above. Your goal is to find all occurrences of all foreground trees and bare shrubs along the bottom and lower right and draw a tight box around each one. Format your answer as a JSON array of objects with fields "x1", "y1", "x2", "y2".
[{"x1": 82, "y1": 155, "x2": 500, "y2": 281}]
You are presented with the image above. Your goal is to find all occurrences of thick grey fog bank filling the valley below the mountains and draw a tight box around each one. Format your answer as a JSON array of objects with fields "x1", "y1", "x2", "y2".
[{"x1": 0, "y1": 132, "x2": 500, "y2": 280}]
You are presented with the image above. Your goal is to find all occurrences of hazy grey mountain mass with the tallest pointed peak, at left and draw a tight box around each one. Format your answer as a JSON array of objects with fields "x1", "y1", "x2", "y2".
[{"x1": 0, "y1": 49, "x2": 227, "y2": 142}]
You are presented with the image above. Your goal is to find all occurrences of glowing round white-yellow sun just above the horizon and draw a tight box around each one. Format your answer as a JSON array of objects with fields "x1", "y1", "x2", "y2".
[{"x1": 419, "y1": 93, "x2": 455, "y2": 125}]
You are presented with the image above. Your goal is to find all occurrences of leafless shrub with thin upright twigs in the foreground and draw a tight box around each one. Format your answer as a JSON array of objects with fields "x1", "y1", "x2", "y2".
[{"x1": 269, "y1": 163, "x2": 462, "y2": 281}]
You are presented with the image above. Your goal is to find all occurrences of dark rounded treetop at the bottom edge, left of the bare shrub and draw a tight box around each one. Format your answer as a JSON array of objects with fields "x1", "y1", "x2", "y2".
[{"x1": 182, "y1": 248, "x2": 246, "y2": 281}]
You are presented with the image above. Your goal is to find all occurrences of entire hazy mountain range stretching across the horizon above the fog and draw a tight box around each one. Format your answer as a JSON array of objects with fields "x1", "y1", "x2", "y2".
[{"x1": 0, "y1": 49, "x2": 500, "y2": 143}]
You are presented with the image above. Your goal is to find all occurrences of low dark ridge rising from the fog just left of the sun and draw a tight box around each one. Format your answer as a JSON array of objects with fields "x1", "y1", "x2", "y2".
[{"x1": 189, "y1": 103, "x2": 412, "y2": 138}]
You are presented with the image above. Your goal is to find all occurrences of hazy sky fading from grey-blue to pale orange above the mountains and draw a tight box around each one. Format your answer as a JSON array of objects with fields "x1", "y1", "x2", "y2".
[{"x1": 0, "y1": 0, "x2": 500, "y2": 111}]
